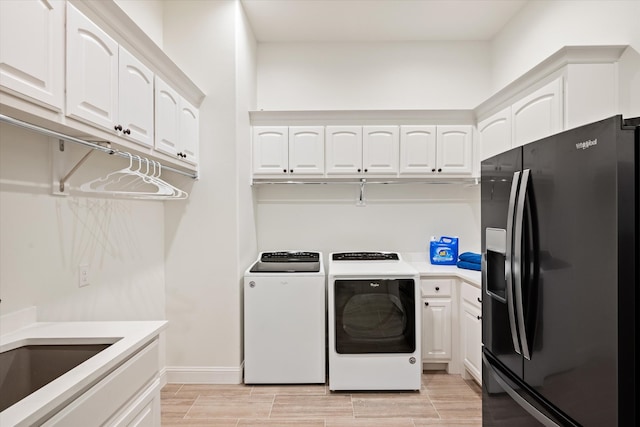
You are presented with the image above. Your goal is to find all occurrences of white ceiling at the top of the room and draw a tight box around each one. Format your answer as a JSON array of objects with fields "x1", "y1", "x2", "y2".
[{"x1": 241, "y1": 0, "x2": 529, "y2": 42}]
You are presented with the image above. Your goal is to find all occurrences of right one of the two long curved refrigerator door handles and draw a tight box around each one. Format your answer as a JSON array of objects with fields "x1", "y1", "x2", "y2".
[{"x1": 512, "y1": 169, "x2": 531, "y2": 360}]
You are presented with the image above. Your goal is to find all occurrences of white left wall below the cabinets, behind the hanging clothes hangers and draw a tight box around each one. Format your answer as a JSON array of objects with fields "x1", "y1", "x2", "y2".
[{"x1": 0, "y1": 124, "x2": 165, "y2": 321}]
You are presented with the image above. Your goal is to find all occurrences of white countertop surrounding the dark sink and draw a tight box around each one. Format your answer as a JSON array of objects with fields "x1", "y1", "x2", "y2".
[{"x1": 0, "y1": 321, "x2": 167, "y2": 426}]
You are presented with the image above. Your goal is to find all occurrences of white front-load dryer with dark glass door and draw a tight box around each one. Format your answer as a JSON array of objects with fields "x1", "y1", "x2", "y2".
[{"x1": 327, "y1": 252, "x2": 422, "y2": 390}]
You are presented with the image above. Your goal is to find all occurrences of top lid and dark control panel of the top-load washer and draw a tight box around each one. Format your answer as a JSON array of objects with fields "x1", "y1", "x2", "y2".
[{"x1": 249, "y1": 251, "x2": 320, "y2": 273}]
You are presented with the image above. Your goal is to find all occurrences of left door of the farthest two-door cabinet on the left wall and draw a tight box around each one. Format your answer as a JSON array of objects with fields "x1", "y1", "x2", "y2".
[{"x1": 155, "y1": 77, "x2": 180, "y2": 156}]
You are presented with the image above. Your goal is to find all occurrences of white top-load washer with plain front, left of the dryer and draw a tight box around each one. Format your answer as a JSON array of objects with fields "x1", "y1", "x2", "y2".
[{"x1": 244, "y1": 251, "x2": 326, "y2": 384}]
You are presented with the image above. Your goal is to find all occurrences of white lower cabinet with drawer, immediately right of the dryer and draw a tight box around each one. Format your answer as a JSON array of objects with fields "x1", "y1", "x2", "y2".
[{"x1": 420, "y1": 279, "x2": 452, "y2": 363}]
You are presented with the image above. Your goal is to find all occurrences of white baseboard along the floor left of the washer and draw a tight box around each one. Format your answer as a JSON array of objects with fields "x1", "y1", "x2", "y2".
[{"x1": 161, "y1": 366, "x2": 243, "y2": 384}]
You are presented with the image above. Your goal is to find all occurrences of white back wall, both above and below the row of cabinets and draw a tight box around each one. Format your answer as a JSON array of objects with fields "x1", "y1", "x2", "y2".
[{"x1": 256, "y1": 42, "x2": 490, "y2": 253}]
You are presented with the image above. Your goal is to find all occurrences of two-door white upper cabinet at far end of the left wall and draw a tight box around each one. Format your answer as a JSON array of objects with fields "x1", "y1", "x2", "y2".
[{"x1": 155, "y1": 76, "x2": 200, "y2": 164}]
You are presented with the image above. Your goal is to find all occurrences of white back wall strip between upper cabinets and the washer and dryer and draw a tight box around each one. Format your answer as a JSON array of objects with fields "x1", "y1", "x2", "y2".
[{"x1": 257, "y1": 184, "x2": 480, "y2": 260}]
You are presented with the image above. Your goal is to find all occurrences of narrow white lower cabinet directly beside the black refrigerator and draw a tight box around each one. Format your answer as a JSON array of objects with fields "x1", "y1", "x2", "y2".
[{"x1": 460, "y1": 282, "x2": 482, "y2": 384}]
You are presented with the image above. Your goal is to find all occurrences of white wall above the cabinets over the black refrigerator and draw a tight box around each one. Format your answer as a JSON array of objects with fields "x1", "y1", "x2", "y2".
[{"x1": 491, "y1": 0, "x2": 640, "y2": 116}]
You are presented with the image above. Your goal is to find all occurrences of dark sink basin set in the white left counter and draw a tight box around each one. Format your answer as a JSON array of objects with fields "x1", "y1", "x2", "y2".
[{"x1": 0, "y1": 343, "x2": 112, "y2": 412}]
